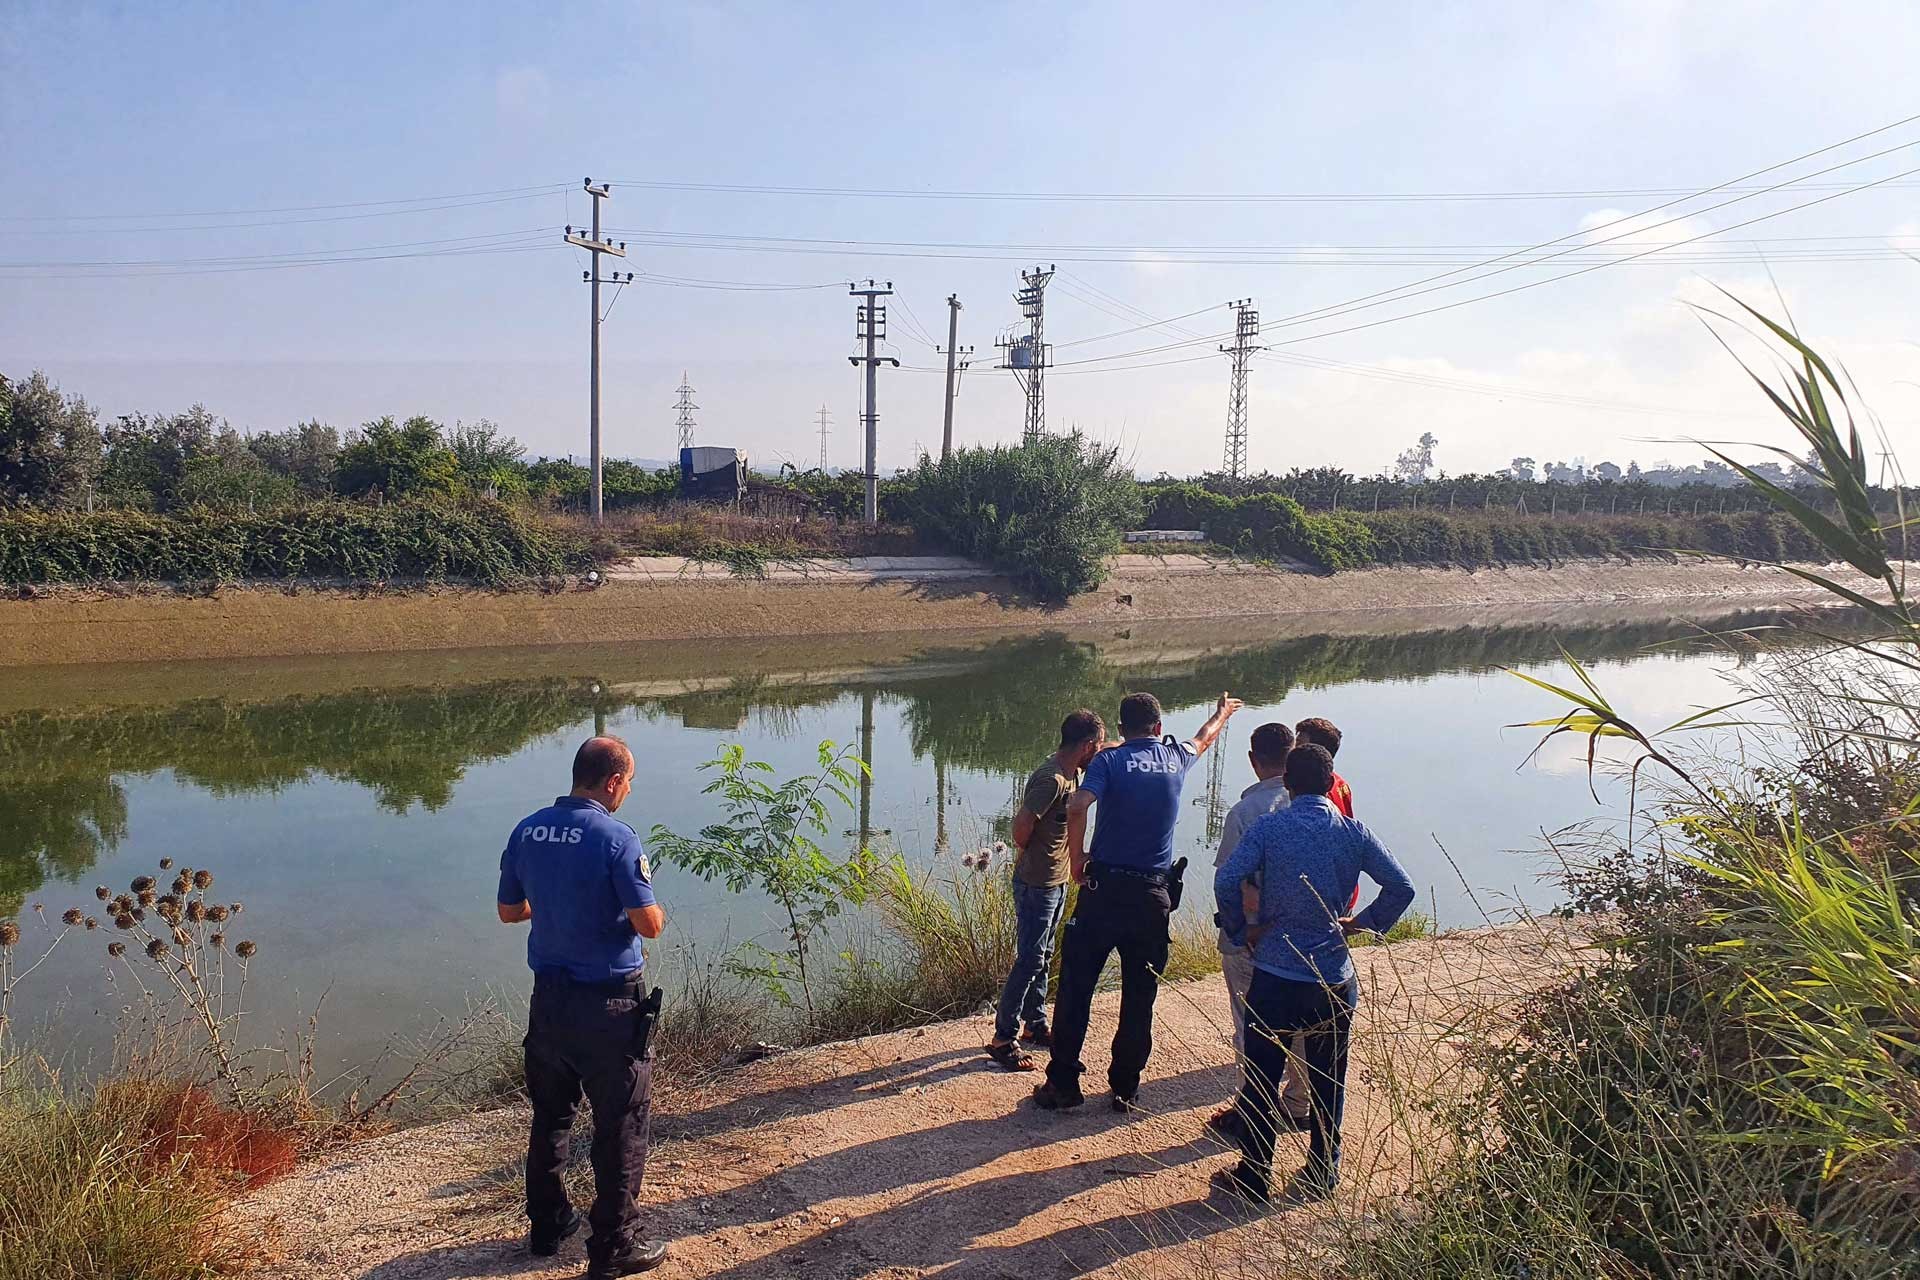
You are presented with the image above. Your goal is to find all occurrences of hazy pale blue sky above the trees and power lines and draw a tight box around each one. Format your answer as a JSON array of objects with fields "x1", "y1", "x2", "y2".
[{"x1": 0, "y1": 0, "x2": 1920, "y2": 472}]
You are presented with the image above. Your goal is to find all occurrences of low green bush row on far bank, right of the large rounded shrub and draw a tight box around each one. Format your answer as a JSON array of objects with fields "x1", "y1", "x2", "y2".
[{"x1": 1146, "y1": 484, "x2": 1828, "y2": 572}]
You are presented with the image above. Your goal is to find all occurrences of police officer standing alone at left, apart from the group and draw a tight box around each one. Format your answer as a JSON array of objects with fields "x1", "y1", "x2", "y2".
[{"x1": 499, "y1": 737, "x2": 666, "y2": 1280}]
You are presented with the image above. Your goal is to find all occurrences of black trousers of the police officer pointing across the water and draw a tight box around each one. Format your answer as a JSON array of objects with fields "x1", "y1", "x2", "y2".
[{"x1": 1046, "y1": 871, "x2": 1173, "y2": 1098}]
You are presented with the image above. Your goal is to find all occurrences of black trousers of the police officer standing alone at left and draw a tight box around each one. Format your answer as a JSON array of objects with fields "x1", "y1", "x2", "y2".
[{"x1": 524, "y1": 973, "x2": 653, "y2": 1265}]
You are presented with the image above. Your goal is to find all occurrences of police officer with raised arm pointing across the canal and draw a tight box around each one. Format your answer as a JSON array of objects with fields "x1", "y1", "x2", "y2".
[{"x1": 1033, "y1": 693, "x2": 1240, "y2": 1111}]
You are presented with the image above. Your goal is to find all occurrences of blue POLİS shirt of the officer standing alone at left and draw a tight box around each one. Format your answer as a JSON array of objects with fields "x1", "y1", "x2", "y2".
[{"x1": 499, "y1": 796, "x2": 655, "y2": 983}]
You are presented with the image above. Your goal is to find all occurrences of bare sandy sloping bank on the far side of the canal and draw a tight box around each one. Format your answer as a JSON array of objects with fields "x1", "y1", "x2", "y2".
[{"x1": 0, "y1": 555, "x2": 1870, "y2": 668}]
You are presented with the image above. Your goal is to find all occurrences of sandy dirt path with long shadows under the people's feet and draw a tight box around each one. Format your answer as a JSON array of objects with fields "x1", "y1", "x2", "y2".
[{"x1": 242, "y1": 925, "x2": 1574, "y2": 1280}]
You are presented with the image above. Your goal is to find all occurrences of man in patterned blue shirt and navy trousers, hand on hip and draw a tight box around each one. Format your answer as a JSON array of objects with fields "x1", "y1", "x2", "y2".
[{"x1": 1213, "y1": 747, "x2": 1413, "y2": 1201}]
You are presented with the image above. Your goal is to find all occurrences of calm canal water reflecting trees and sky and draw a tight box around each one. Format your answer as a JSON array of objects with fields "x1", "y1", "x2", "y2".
[{"x1": 0, "y1": 606, "x2": 1797, "y2": 1069}]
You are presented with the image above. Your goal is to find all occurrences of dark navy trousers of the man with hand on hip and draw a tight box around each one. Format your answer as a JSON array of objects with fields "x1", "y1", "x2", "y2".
[{"x1": 1240, "y1": 969, "x2": 1359, "y2": 1190}]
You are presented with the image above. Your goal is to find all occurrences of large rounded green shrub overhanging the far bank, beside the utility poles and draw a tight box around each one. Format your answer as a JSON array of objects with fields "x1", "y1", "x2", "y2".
[{"x1": 900, "y1": 432, "x2": 1142, "y2": 601}]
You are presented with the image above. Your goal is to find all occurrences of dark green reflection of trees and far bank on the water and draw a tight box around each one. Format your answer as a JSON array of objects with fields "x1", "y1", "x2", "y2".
[{"x1": 0, "y1": 614, "x2": 1812, "y2": 915}]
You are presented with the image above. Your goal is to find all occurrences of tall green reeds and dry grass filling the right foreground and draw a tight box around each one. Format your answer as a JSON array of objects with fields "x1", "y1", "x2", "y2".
[{"x1": 1338, "y1": 309, "x2": 1920, "y2": 1280}]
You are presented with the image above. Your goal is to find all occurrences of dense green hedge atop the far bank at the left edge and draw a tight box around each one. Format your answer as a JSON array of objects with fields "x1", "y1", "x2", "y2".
[{"x1": 0, "y1": 499, "x2": 589, "y2": 585}]
